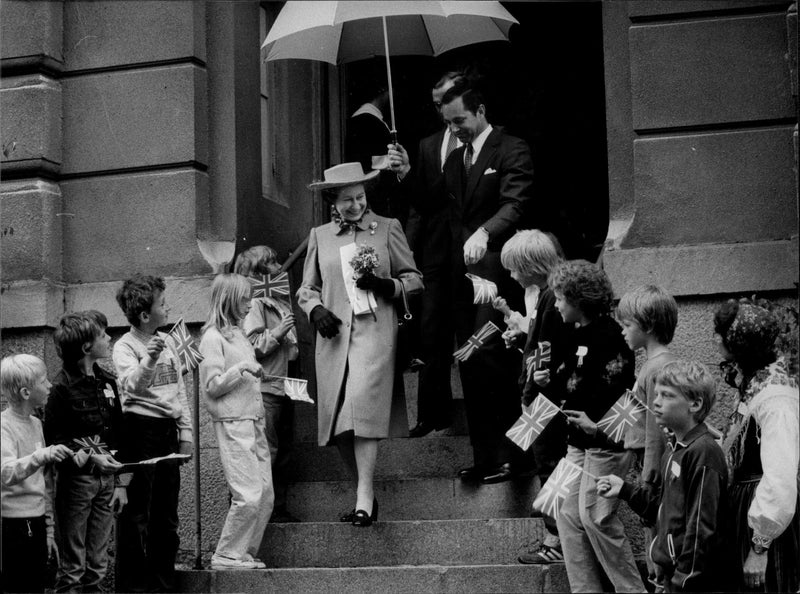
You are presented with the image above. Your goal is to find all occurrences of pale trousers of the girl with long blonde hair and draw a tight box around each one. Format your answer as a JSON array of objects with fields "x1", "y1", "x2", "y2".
[{"x1": 214, "y1": 419, "x2": 275, "y2": 559}]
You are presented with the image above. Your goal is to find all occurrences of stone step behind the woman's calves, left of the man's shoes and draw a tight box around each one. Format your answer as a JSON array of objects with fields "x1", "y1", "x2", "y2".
[{"x1": 289, "y1": 431, "x2": 472, "y2": 482}]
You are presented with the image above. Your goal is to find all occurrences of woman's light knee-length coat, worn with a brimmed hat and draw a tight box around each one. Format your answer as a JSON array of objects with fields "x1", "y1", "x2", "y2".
[{"x1": 297, "y1": 212, "x2": 422, "y2": 445}]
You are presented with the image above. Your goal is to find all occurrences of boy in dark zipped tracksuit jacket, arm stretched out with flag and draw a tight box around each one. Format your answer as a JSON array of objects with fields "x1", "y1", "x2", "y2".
[{"x1": 597, "y1": 361, "x2": 733, "y2": 592}]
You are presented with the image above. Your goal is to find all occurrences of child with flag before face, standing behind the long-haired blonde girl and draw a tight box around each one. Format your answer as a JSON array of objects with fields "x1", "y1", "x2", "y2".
[{"x1": 238, "y1": 245, "x2": 299, "y2": 522}]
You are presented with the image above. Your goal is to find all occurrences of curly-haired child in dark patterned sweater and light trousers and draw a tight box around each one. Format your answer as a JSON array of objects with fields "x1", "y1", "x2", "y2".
[{"x1": 534, "y1": 260, "x2": 644, "y2": 592}]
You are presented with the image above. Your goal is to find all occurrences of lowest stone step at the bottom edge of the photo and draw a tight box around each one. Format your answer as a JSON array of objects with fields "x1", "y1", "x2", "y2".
[{"x1": 178, "y1": 564, "x2": 569, "y2": 594}]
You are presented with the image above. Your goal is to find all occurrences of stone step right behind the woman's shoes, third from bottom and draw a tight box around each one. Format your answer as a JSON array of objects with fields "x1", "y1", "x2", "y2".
[{"x1": 287, "y1": 477, "x2": 538, "y2": 522}]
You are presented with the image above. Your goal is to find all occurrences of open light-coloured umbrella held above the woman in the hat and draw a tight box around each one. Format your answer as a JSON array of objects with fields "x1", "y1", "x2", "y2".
[{"x1": 261, "y1": 0, "x2": 518, "y2": 136}]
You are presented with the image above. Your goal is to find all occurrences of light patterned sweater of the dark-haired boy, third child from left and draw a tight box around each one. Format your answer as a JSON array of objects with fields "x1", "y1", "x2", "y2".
[{"x1": 113, "y1": 327, "x2": 192, "y2": 441}]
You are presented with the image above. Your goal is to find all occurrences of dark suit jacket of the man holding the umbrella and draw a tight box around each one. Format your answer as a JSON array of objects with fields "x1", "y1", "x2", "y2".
[{"x1": 443, "y1": 128, "x2": 533, "y2": 280}]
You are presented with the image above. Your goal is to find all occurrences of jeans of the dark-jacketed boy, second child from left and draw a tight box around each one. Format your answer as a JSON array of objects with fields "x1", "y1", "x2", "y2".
[{"x1": 55, "y1": 470, "x2": 114, "y2": 592}]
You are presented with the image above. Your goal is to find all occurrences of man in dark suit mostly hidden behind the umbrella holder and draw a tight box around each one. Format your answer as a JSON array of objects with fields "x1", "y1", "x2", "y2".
[{"x1": 404, "y1": 71, "x2": 461, "y2": 437}]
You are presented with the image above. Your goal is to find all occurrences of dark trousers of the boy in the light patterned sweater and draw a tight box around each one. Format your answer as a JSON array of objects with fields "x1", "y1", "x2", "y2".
[{"x1": 116, "y1": 413, "x2": 181, "y2": 592}]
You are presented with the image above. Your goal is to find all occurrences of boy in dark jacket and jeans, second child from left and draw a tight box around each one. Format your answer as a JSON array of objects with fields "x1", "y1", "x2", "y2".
[{"x1": 44, "y1": 311, "x2": 131, "y2": 592}]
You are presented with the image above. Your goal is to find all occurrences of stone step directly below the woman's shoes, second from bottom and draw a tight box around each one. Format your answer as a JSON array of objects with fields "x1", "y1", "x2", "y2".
[{"x1": 258, "y1": 518, "x2": 544, "y2": 568}]
